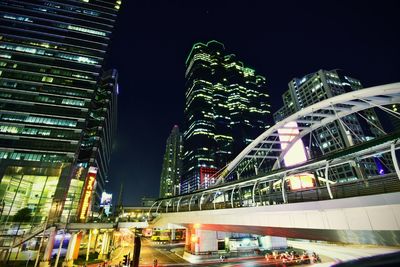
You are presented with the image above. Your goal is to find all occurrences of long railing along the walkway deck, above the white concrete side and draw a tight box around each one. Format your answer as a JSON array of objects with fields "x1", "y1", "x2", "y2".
[{"x1": 157, "y1": 174, "x2": 400, "y2": 213}]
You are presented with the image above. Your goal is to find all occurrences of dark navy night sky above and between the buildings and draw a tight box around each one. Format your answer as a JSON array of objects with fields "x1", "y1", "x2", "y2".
[{"x1": 108, "y1": 0, "x2": 400, "y2": 205}]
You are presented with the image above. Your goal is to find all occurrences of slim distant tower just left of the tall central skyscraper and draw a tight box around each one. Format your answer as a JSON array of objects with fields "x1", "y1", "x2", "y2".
[{"x1": 160, "y1": 125, "x2": 183, "y2": 198}]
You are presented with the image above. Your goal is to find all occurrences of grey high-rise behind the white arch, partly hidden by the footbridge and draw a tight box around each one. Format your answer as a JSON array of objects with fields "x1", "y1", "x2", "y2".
[{"x1": 274, "y1": 70, "x2": 390, "y2": 182}]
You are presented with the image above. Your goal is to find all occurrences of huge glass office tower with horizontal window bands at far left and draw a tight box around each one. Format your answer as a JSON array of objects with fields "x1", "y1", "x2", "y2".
[{"x1": 0, "y1": 0, "x2": 121, "y2": 224}]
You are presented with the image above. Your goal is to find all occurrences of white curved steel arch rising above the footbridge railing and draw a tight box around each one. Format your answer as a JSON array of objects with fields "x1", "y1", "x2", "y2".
[{"x1": 216, "y1": 83, "x2": 400, "y2": 184}]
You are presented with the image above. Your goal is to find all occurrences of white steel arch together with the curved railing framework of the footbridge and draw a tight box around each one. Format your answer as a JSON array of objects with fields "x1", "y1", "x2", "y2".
[{"x1": 148, "y1": 83, "x2": 400, "y2": 216}]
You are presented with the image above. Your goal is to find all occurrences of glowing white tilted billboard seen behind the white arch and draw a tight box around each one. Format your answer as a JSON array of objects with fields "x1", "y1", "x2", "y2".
[{"x1": 278, "y1": 121, "x2": 307, "y2": 167}]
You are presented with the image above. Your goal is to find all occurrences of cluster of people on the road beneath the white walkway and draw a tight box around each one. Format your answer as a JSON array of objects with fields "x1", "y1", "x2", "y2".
[{"x1": 265, "y1": 250, "x2": 321, "y2": 264}]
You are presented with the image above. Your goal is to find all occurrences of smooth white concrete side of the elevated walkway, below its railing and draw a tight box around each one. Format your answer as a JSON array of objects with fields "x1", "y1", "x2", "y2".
[{"x1": 153, "y1": 192, "x2": 400, "y2": 246}]
